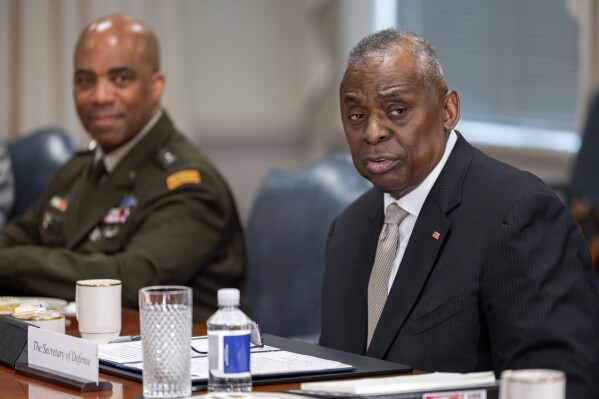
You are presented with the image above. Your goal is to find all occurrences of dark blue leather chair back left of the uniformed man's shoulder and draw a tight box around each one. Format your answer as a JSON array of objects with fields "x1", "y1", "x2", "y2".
[{"x1": 7, "y1": 128, "x2": 77, "y2": 219}]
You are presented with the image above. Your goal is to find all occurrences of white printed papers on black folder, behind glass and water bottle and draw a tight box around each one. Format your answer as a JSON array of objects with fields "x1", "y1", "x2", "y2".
[{"x1": 98, "y1": 337, "x2": 355, "y2": 381}]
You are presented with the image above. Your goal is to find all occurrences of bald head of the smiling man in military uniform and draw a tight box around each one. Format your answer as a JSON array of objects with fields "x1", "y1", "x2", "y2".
[{"x1": 73, "y1": 15, "x2": 164, "y2": 153}]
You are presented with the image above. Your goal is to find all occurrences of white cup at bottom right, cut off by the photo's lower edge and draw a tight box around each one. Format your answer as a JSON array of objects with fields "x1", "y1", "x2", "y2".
[{"x1": 499, "y1": 369, "x2": 566, "y2": 399}]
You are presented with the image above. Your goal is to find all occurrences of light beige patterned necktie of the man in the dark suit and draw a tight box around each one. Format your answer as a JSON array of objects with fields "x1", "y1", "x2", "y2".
[{"x1": 366, "y1": 202, "x2": 408, "y2": 347}]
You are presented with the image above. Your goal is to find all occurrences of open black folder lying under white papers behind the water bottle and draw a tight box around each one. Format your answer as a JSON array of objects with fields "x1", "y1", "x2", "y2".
[{"x1": 100, "y1": 334, "x2": 412, "y2": 391}]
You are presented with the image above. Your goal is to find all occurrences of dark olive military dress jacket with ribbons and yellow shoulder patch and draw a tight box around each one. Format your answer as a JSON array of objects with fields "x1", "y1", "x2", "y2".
[{"x1": 0, "y1": 113, "x2": 245, "y2": 322}]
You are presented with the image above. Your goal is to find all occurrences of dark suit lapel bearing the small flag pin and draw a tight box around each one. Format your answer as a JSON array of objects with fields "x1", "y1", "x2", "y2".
[{"x1": 367, "y1": 133, "x2": 473, "y2": 358}]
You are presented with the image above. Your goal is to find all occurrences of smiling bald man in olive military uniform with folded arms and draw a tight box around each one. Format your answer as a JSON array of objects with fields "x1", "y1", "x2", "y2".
[{"x1": 0, "y1": 15, "x2": 245, "y2": 322}]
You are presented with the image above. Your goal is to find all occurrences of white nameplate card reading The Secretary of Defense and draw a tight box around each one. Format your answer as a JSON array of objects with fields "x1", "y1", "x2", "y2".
[{"x1": 27, "y1": 327, "x2": 99, "y2": 384}]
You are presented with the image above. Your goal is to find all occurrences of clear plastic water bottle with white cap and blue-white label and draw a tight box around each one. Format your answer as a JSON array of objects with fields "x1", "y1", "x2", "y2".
[{"x1": 206, "y1": 288, "x2": 252, "y2": 392}]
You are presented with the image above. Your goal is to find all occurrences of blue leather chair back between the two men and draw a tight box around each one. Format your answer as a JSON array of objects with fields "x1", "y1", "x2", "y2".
[{"x1": 245, "y1": 154, "x2": 372, "y2": 342}]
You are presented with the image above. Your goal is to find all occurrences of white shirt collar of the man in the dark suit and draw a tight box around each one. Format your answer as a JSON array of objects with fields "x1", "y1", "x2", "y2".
[{"x1": 384, "y1": 130, "x2": 458, "y2": 217}]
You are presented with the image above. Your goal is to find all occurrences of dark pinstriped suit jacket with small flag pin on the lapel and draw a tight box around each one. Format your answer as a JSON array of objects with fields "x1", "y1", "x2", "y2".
[{"x1": 321, "y1": 134, "x2": 599, "y2": 398}]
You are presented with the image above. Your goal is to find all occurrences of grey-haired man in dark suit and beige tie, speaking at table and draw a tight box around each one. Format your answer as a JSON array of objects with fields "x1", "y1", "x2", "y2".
[{"x1": 320, "y1": 30, "x2": 599, "y2": 398}]
